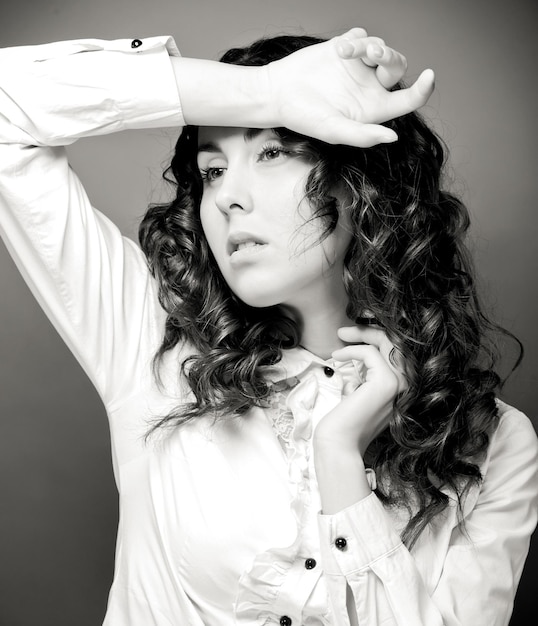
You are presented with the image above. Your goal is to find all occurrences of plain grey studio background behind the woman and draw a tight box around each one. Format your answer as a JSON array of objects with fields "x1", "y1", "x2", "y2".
[{"x1": 0, "y1": 0, "x2": 538, "y2": 626}]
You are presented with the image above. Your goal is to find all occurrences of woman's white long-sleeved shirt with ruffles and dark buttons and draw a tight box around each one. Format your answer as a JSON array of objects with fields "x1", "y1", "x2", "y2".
[{"x1": 0, "y1": 37, "x2": 538, "y2": 626}]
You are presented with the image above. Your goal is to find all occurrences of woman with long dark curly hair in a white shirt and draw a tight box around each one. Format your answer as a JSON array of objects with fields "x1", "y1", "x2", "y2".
[{"x1": 2, "y1": 30, "x2": 537, "y2": 626}]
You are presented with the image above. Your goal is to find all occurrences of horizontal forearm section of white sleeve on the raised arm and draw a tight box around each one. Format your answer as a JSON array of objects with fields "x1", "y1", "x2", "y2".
[{"x1": 0, "y1": 36, "x2": 185, "y2": 146}]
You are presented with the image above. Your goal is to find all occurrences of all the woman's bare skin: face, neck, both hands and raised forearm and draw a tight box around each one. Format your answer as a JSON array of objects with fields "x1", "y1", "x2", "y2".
[{"x1": 186, "y1": 29, "x2": 420, "y2": 625}]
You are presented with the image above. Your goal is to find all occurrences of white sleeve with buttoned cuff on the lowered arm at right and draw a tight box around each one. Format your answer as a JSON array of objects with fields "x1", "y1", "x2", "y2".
[{"x1": 319, "y1": 405, "x2": 538, "y2": 626}]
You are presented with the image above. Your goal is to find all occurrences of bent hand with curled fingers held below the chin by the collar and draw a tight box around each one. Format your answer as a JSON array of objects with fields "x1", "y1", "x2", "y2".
[{"x1": 314, "y1": 326, "x2": 407, "y2": 456}]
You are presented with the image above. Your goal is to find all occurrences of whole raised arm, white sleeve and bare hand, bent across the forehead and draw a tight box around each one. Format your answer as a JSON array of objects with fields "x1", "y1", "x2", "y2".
[{"x1": 0, "y1": 29, "x2": 433, "y2": 402}]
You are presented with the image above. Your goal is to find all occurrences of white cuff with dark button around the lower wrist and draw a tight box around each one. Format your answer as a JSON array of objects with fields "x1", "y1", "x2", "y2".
[{"x1": 318, "y1": 492, "x2": 402, "y2": 576}]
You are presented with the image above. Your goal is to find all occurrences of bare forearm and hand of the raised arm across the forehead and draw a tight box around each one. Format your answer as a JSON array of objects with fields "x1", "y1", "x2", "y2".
[{"x1": 171, "y1": 28, "x2": 434, "y2": 147}]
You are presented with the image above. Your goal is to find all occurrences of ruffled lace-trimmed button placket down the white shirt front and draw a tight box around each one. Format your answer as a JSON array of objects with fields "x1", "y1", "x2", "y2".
[{"x1": 235, "y1": 363, "x2": 362, "y2": 626}]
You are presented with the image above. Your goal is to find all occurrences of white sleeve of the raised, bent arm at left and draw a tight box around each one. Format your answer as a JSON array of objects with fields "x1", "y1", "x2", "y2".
[{"x1": 0, "y1": 37, "x2": 184, "y2": 405}]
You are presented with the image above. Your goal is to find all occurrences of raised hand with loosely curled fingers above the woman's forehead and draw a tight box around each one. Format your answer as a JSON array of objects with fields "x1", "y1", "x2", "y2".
[{"x1": 264, "y1": 28, "x2": 434, "y2": 148}]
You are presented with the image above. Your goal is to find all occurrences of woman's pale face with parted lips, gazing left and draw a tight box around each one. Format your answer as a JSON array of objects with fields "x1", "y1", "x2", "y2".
[{"x1": 198, "y1": 127, "x2": 351, "y2": 309}]
